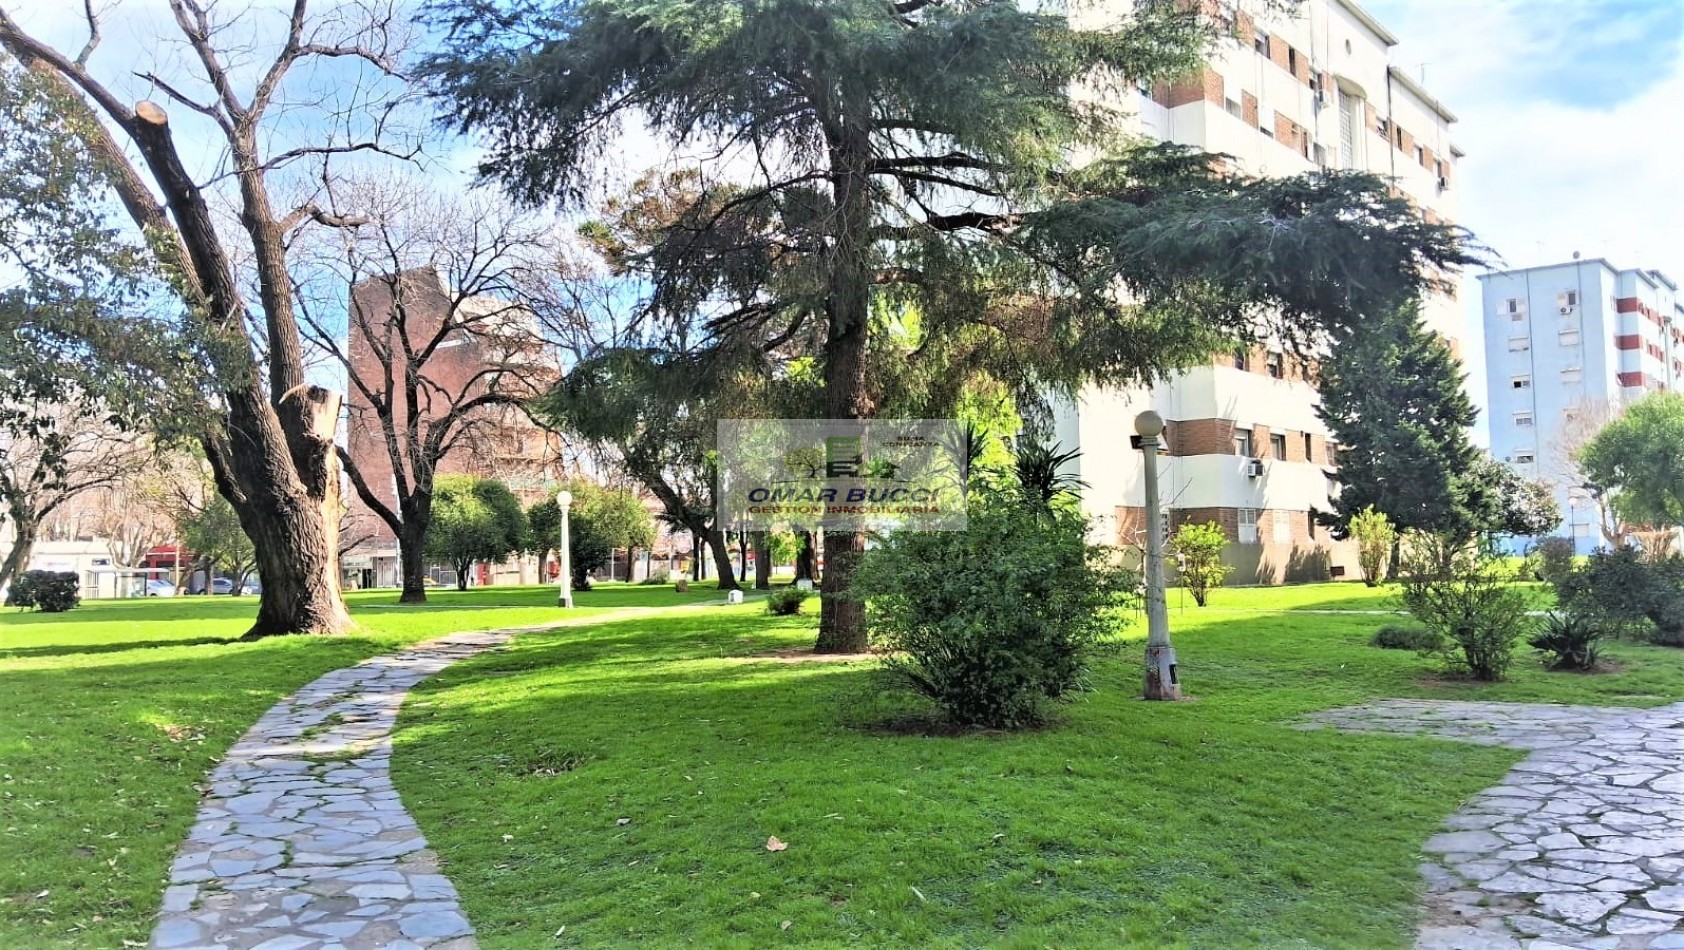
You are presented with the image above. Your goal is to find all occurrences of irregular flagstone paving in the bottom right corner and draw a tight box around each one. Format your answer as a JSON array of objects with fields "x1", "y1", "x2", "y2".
[{"x1": 1305, "y1": 699, "x2": 1684, "y2": 950}]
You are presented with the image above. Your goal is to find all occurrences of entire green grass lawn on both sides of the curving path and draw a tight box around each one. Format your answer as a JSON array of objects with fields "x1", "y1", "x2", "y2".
[{"x1": 0, "y1": 584, "x2": 1684, "y2": 948}]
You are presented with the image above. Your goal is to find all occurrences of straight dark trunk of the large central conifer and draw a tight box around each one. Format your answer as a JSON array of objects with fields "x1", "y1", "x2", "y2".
[{"x1": 813, "y1": 105, "x2": 872, "y2": 654}]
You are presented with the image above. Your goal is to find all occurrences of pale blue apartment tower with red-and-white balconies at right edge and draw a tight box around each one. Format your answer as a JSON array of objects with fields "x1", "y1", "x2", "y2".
[{"x1": 1480, "y1": 258, "x2": 1684, "y2": 554}]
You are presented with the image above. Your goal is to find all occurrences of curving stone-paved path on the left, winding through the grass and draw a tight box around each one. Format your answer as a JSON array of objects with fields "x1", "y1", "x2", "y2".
[{"x1": 152, "y1": 630, "x2": 515, "y2": 950}]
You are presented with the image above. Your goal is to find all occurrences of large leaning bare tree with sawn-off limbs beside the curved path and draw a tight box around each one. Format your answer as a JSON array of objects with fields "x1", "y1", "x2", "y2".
[{"x1": 0, "y1": 0, "x2": 413, "y2": 637}]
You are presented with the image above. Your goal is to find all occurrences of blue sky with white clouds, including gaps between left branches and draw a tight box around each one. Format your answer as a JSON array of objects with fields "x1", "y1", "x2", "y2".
[{"x1": 13, "y1": 0, "x2": 1684, "y2": 417}]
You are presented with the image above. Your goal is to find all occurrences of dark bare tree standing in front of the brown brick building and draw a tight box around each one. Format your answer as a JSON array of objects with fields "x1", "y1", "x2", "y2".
[{"x1": 298, "y1": 180, "x2": 561, "y2": 603}]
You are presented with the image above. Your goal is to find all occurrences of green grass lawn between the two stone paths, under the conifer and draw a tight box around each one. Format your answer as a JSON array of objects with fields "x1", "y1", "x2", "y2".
[{"x1": 396, "y1": 584, "x2": 1684, "y2": 948}]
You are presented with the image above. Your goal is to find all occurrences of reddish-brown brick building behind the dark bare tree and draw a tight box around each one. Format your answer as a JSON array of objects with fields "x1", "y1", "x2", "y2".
[{"x1": 342, "y1": 268, "x2": 568, "y2": 586}]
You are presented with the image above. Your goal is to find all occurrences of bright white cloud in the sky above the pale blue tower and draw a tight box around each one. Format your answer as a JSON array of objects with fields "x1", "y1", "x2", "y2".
[{"x1": 1372, "y1": 0, "x2": 1684, "y2": 441}]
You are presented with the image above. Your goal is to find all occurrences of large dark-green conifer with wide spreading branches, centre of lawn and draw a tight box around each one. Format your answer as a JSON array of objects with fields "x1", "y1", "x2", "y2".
[{"x1": 426, "y1": 0, "x2": 1463, "y2": 652}]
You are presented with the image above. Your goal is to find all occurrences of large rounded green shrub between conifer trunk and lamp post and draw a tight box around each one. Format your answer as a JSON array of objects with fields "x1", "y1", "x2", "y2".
[{"x1": 850, "y1": 495, "x2": 1132, "y2": 729}]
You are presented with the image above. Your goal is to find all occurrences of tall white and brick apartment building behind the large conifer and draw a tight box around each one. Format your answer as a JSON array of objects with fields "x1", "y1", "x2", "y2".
[{"x1": 1054, "y1": 0, "x2": 1463, "y2": 583}]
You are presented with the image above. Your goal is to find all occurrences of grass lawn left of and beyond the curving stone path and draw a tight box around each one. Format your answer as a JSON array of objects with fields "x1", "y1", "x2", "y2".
[{"x1": 0, "y1": 584, "x2": 719, "y2": 948}]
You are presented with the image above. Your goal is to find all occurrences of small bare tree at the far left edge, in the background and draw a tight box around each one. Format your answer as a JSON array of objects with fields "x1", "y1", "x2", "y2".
[{"x1": 0, "y1": 406, "x2": 152, "y2": 588}]
